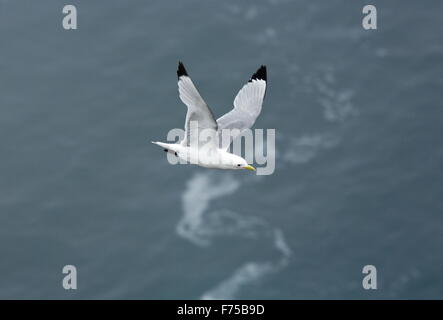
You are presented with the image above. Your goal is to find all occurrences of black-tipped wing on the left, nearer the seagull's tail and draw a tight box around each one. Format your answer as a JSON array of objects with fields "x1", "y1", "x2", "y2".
[{"x1": 177, "y1": 62, "x2": 217, "y2": 148}]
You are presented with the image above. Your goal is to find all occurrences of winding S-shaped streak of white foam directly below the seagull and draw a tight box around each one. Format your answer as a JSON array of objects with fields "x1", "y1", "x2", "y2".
[{"x1": 177, "y1": 172, "x2": 291, "y2": 299}]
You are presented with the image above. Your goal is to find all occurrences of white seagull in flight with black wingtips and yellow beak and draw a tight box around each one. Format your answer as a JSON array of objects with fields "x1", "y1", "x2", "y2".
[{"x1": 152, "y1": 62, "x2": 267, "y2": 171}]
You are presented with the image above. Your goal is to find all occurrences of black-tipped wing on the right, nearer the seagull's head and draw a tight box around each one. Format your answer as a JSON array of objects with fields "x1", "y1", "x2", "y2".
[{"x1": 217, "y1": 66, "x2": 267, "y2": 149}]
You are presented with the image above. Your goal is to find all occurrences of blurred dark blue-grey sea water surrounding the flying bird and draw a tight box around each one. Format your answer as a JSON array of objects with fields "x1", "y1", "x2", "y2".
[{"x1": 0, "y1": 0, "x2": 443, "y2": 299}]
